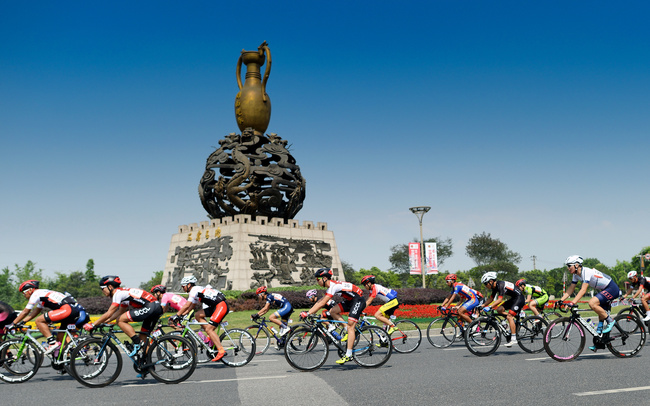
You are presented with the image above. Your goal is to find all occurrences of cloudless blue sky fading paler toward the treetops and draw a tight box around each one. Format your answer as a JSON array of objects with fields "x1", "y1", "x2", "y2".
[{"x1": 0, "y1": 1, "x2": 650, "y2": 285}]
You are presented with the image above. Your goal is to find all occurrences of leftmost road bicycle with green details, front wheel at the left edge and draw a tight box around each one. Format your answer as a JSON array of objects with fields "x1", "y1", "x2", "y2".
[{"x1": 0, "y1": 324, "x2": 83, "y2": 383}]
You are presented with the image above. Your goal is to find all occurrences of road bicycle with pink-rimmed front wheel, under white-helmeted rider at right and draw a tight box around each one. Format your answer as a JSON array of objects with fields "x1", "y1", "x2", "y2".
[{"x1": 544, "y1": 305, "x2": 646, "y2": 362}]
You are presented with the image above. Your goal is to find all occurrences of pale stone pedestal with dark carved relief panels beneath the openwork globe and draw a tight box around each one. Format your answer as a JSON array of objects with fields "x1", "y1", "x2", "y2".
[{"x1": 162, "y1": 214, "x2": 345, "y2": 292}]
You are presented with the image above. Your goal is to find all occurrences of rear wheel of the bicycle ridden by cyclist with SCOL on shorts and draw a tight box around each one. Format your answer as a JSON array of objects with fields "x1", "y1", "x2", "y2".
[{"x1": 148, "y1": 334, "x2": 196, "y2": 383}]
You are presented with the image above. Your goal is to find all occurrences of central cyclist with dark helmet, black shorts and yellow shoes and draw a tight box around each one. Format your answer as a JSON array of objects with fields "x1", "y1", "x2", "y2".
[{"x1": 300, "y1": 268, "x2": 366, "y2": 364}]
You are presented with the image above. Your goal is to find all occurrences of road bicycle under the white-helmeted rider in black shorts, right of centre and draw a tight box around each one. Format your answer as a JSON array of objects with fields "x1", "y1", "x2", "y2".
[{"x1": 465, "y1": 310, "x2": 548, "y2": 357}]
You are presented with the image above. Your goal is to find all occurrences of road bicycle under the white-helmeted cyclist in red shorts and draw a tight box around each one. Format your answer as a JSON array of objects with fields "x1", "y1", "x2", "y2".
[{"x1": 158, "y1": 313, "x2": 256, "y2": 367}]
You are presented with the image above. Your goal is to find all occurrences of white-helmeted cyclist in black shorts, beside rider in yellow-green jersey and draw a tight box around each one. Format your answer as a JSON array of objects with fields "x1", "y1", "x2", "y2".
[{"x1": 481, "y1": 272, "x2": 526, "y2": 347}]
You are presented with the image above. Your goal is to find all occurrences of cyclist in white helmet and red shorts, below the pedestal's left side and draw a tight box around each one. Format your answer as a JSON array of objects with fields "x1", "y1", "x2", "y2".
[{"x1": 170, "y1": 276, "x2": 229, "y2": 362}]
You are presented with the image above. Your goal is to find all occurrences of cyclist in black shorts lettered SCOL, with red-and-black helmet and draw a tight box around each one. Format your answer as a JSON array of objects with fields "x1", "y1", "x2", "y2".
[{"x1": 84, "y1": 275, "x2": 163, "y2": 357}]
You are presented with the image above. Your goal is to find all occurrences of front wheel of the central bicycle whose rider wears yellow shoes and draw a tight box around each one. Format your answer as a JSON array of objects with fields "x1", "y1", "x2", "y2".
[{"x1": 284, "y1": 326, "x2": 329, "y2": 371}]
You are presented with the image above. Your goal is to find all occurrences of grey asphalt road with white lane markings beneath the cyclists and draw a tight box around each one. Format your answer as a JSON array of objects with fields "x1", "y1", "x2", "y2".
[{"x1": 0, "y1": 337, "x2": 650, "y2": 406}]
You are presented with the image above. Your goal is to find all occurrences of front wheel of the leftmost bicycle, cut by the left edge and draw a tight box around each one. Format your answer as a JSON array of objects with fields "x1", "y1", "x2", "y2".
[{"x1": 0, "y1": 338, "x2": 42, "y2": 383}]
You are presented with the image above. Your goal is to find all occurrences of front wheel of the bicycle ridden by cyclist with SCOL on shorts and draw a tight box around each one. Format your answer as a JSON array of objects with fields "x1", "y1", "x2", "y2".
[{"x1": 70, "y1": 338, "x2": 122, "y2": 388}]
